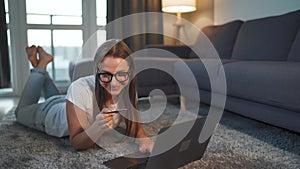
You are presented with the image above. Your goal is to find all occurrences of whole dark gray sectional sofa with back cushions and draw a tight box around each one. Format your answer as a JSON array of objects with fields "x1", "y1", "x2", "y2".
[{"x1": 70, "y1": 10, "x2": 300, "y2": 133}]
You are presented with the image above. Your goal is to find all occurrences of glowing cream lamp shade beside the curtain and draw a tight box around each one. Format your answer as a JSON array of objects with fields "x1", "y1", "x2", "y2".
[{"x1": 162, "y1": 0, "x2": 196, "y2": 13}]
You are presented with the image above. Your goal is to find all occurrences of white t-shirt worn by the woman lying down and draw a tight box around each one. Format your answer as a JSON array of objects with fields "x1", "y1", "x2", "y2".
[{"x1": 66, "y1": 75, "x2": 100, "y2": 127}]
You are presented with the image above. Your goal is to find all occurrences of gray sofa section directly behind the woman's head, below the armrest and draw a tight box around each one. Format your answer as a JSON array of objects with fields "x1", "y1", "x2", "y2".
[{"x1": 69, "y1": 56, "x2": 177, "y2": 98}]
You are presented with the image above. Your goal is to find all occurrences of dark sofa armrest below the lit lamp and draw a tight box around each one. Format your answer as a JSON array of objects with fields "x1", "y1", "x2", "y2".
[{"x1": 145, "y1": 44, "x2": 191, "y2": 58}]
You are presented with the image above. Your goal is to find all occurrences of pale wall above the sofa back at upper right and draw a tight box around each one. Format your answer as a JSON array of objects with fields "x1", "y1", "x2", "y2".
[{"x1": 214, "y1": 0, "x2": 300, "y2": 24}]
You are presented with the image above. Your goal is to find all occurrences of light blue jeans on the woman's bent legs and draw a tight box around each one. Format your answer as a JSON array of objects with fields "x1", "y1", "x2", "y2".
[{"x1": 15, "y1": 68, "x2": 61, "y2": 132}]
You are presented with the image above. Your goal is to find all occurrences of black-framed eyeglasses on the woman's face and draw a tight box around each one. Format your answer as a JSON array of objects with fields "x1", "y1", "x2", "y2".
[{"x1": 97, "y1": 72, "x2": 129, "y2": 83}]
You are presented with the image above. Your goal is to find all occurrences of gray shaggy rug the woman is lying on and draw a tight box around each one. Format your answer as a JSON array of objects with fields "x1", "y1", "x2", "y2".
[{"x1": 0, "y1": 101, "x2": 300, "y2": 169}]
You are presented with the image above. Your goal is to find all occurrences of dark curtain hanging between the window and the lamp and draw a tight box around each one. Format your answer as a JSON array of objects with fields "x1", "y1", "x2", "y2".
[{"x1": 107, "y1": 0, "x2": 163, "y2": 51}]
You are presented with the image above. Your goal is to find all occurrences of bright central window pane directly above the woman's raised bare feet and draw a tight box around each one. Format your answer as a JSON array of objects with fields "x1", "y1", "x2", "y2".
[{"x1": 26, "y1": 0, "x2": 83, "y2": 82}]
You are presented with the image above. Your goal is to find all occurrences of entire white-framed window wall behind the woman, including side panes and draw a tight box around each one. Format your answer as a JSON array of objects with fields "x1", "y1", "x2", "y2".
[{"x1": 4, "y1": 0, "x2": 106, "y2": 95}]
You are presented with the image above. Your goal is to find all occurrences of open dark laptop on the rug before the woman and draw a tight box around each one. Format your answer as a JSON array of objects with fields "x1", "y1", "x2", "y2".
[{"x1": 103, "y1": 117, "x2": 210, "y2": 169}]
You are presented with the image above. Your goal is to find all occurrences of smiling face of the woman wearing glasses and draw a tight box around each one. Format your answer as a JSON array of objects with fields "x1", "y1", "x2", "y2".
[{"x1": 98, "y1": 56, "x2": 129, "y2": 97}]
